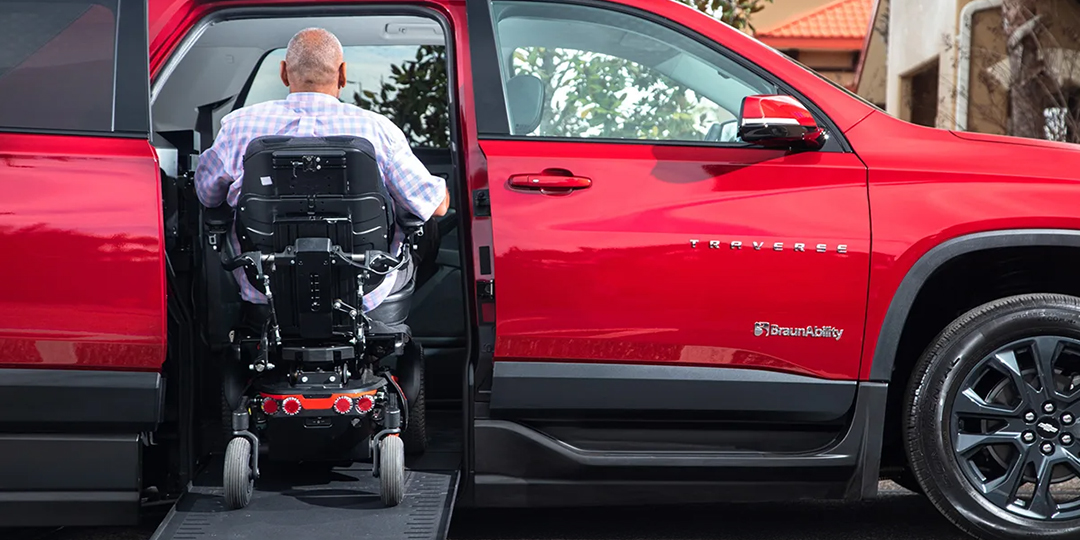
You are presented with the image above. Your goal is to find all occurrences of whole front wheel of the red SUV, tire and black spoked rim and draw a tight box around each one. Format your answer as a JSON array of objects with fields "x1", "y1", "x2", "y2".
[{"x1": 903, "y1": 294, "x2": 1080, "y2": 540}]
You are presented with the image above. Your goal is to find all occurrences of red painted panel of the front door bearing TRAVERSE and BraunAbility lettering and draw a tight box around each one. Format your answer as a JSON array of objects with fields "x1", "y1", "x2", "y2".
[{"x1": 481, "y1": 141, "x2": 869, "y2": 379}]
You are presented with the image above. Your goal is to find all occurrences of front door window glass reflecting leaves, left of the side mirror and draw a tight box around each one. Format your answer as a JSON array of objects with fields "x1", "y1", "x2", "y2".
[{"x1": 492, "y1": 0, "x2": 778, "y2": 141}]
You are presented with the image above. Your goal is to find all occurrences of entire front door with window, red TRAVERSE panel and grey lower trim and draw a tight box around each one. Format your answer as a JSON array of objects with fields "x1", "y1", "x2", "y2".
[{"x1": 470, "y1": 0, "x2": 869, "y2": 425}]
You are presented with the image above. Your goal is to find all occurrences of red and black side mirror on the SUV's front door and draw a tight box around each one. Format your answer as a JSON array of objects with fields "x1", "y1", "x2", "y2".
[{"x1": 739, "y1": 95, "x2": 826, "y2": 150}]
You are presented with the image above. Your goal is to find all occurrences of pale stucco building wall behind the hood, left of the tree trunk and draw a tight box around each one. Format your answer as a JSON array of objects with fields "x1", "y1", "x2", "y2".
[{"x1": 886, "y1": 0, "x2": 968, "y2": 116}]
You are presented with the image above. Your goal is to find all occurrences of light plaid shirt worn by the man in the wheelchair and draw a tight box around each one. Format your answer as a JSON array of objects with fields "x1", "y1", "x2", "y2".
[{"x1": 195, "y1": 92, "x2": 445, "y2": 311}]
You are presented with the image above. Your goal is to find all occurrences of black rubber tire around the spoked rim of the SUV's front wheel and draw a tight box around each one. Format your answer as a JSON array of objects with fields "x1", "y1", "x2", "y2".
[{"x1": 905, "y1": 297, "x2": 1080, "y2": 538}]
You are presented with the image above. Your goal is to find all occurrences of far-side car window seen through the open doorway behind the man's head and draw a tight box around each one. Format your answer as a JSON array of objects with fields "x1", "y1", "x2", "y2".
[{"x1": 243, "y1": 44, "x2": 450, "y2": 149}]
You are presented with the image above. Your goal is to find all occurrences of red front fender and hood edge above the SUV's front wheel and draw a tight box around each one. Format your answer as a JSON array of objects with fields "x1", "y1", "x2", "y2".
[{"x1": 847, "y1": 112, "x2": 1080, "y2": 378}]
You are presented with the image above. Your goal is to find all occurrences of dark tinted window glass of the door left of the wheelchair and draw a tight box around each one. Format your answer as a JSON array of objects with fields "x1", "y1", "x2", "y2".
[{"x1": 0, "y1": 0, "x2": 117, "y2": 132}]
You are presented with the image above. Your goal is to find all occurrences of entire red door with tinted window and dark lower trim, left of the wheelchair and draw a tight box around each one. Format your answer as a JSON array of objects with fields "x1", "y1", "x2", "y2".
[{"x1": 0, "y1": 0, "x2": 165, "y2": 525}]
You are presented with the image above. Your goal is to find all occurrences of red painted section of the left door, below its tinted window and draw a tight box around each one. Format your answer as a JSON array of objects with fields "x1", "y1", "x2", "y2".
[{"x1": 0, "y1": 134, "x2": 165, "y2": 372}]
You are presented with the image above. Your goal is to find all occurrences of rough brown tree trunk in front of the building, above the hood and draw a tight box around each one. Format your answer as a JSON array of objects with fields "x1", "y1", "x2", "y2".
[{"x1": 1001, "y1": 0, "x2": 1050, "y2": 138}]
